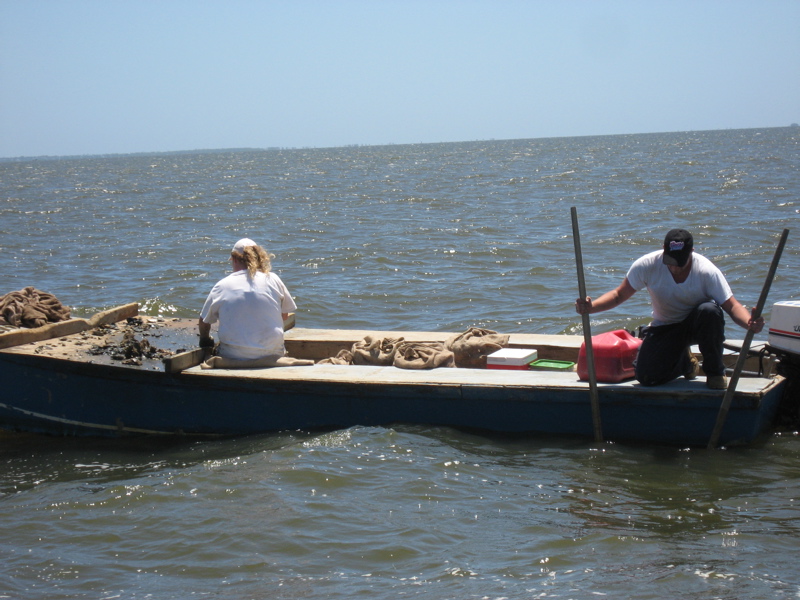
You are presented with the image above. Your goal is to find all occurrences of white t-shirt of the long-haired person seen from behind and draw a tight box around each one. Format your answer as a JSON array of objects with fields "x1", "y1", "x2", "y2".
[{"x1": 200, "y1": 269, "x2": 297, "y2": 359}]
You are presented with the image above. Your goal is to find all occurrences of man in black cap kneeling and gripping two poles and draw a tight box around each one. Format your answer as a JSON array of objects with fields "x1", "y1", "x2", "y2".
[{"x1": 575, "y1": 229, "x2": 764, "y2": 389}]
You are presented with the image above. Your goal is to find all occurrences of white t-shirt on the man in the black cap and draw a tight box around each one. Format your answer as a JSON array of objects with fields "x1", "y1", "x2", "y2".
[{"x1": 627, "y1": 250, "x2": 733, "y2": 326}]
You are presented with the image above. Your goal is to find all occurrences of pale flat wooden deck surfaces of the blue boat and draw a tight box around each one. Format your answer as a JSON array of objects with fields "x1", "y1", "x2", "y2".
[{"x1": 0, "y1": 317, "x2": 773, "y2": 395}]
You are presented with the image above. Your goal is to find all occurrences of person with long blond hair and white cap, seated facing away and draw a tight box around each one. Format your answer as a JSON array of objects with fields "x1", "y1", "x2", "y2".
[{"x1": 198, "y1": 238, "x2": 314, "y2": 369}]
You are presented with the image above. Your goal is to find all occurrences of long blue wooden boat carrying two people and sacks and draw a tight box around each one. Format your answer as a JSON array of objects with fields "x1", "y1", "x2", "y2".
[{"x1": 0, "y1": 308, "x2": 786, "y2": 447}]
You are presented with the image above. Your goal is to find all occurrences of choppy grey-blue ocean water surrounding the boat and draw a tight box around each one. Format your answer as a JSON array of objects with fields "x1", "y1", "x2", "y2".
[{"x1": 0, "y1": 128, "x2": 800, "y2": 599}]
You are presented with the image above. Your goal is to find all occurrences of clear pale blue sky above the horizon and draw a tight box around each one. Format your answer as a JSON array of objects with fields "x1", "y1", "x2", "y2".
[{"x1": 0, "y1": 0, "x2": 800, "y2": 158}]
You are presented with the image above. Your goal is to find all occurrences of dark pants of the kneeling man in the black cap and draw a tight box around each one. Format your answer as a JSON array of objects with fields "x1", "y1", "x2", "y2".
[{"x1": 636, "y1": 302, "x2": 725, "y2": 385}]
